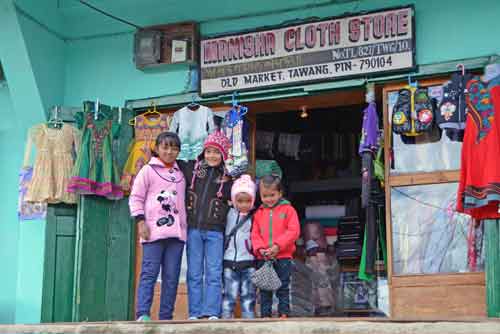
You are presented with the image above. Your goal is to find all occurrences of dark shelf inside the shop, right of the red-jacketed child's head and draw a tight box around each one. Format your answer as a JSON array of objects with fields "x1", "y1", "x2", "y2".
[{"x1": 290, "y1": 176, "x2": 361, "y2": 193}]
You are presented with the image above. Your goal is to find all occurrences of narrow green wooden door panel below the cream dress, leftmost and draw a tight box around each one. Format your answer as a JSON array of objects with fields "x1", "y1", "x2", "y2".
[{"x1": 42, "y1": 204, "x2": 76, "y2": 322}]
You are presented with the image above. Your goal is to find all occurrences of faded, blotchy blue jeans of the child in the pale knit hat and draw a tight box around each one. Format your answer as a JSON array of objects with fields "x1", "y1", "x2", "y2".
[{"x1": 222, "y1": 268, "x2": 255, "y2": 319}]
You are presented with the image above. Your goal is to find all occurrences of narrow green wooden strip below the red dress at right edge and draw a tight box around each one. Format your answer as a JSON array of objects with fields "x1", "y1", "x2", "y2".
[{"x1": 484, "y1": 220, "x2": 500, "y2": 318}]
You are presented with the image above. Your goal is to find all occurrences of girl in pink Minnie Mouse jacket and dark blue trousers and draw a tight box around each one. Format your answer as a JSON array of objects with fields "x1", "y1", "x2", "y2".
[{"x1": 129, "y1": 132, "x2": 187, "y2": 321}]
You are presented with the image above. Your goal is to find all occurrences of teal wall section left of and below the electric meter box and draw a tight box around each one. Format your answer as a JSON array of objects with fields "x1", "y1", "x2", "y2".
[{"x1": 64, "y1": 34, "x2": 188, "y2": 106}]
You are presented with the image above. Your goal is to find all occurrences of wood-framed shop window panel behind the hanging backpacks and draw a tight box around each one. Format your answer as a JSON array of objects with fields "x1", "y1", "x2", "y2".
[{"x1": 383, "y1": 78, "x2": 485, "y2": 318}]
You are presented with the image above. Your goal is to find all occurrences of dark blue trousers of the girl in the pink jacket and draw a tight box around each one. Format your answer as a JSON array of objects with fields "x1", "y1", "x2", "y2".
[{"x1": 136, "y1": 238, "x2": 184, "y2": 320}]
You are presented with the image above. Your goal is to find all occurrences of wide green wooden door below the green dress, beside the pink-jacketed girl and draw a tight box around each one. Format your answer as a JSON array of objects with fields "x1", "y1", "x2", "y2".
[{"x1": 73, "y1": 105, "x2": 135, "y2": 321}]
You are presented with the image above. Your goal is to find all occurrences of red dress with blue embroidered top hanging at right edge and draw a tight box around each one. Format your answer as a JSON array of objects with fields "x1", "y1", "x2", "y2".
[{"x1": 457, "y1": 71, "x2": 500, "y2": 219}]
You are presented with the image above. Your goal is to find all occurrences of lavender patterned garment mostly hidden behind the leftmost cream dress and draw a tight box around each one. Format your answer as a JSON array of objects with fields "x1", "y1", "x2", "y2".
[{"x1": 17, "y1": 166, "x2": 47, "y2": 220}]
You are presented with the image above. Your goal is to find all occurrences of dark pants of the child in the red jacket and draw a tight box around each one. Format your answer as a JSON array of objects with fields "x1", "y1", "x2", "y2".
[{"x1": 257, "y1": 259, "x2": 292, "y2": 318}]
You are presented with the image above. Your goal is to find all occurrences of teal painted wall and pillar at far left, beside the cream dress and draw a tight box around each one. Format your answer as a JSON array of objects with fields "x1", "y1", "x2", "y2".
[{"x1": 0, "y1": 0, "x2": 65, "y2": 323}]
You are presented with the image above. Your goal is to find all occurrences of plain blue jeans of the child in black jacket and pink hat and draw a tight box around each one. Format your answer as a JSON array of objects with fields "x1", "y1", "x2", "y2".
[{"x1": 187, "y1": 228, "x2": 224, "y2": 318}]
